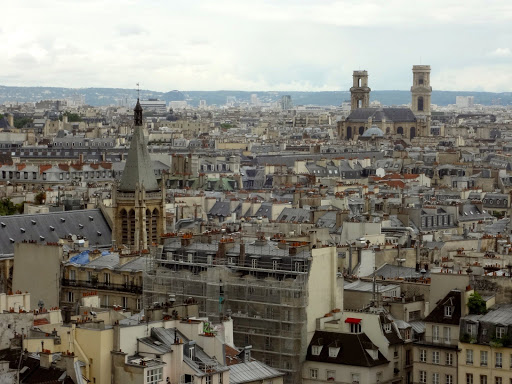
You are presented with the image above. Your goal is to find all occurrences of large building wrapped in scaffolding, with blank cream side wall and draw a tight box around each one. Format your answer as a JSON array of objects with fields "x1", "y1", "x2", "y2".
[{"x1": 144, "y1": 234, "x2": 343, "y2": 383}]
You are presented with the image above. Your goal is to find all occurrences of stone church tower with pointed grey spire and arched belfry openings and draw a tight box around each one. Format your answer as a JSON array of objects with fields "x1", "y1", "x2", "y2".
[{"x1": 112, "y1": 99, "x2": 165, "y2": 251}]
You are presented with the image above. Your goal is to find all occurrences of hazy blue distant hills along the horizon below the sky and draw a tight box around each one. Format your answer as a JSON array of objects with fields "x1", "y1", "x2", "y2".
[{"x1": 0, "y1": 86, "x2": 512, "y2": 106}]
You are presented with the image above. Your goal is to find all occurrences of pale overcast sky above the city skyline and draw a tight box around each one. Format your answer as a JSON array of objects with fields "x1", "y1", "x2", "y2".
[{"x1": 4, "y1": 0, "x2": 512, "y2": 92}]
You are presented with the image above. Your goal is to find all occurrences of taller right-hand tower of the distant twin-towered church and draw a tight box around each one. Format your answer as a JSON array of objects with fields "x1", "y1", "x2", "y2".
[{"x1": 411, "y1": 65, "x2": 432, "y2": 136}]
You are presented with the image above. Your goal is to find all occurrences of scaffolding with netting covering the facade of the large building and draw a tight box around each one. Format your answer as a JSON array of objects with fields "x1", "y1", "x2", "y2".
[{"x1": 144, "y1": 243, "x2": 311, "y2": 383}]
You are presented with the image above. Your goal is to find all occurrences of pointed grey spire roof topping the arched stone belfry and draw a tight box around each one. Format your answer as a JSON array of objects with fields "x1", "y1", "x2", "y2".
[{"x1": 119, "y1": 99, "x2": 159, "y2": 192}]
